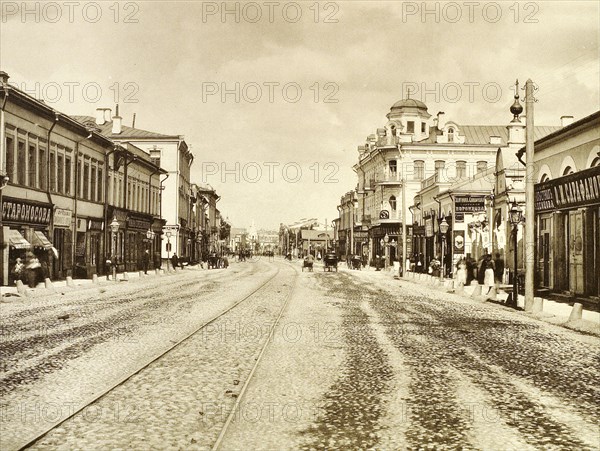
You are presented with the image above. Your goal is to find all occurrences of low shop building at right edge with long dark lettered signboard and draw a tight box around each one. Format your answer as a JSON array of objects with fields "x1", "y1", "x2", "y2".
[{"x1": 519, "y1": 111, "x2": 600, "y2": 305}]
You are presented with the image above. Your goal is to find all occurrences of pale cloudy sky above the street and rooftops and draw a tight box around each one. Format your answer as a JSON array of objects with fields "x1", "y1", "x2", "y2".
[{"x1": 0, "y1": 1, "x2": 600, "y2": 228}]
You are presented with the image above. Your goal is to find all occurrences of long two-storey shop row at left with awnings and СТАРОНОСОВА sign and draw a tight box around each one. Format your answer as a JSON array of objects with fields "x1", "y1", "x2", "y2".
[{"x1": 0, "y1": 72, "x2": 165, "y2": 284}]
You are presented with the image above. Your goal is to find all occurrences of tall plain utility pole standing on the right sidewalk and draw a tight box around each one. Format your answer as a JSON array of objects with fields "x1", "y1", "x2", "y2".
[{"x1": 515, "y1": 79, "x2": 536, "y2": 312}]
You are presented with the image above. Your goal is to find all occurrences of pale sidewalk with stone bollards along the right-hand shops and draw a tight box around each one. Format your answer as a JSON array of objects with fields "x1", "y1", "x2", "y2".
[{"x1": 400, "y1": 272, "x2": 600, "y2": 336}]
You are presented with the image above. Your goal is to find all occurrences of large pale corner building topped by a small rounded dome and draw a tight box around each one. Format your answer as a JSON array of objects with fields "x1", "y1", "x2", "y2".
[{"x1": 350, "y1": 92, "x2": 559, "y2": 265}]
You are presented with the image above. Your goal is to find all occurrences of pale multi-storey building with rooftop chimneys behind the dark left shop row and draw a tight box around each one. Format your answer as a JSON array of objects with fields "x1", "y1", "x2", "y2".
[{"x1": 77, "y1": 105, "x2": 195, "y2": 260}]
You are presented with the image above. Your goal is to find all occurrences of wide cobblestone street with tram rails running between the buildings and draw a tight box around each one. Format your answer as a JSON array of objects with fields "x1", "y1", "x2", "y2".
[{"x1": 0, "y1": 259, "x2": 600, "y2": 451}]
